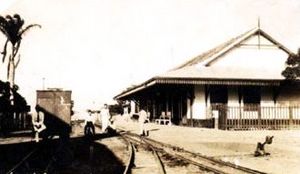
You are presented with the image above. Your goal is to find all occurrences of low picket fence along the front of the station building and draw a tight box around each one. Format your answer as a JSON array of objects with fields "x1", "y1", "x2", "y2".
[{"x1": 209, "y1": 105, "x2": 300, "y2": 130}]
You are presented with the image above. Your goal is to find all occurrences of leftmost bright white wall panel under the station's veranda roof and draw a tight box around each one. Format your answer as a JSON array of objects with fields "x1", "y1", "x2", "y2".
[{"x1": 192, "y1": 85, "x2": 206, "y2": 119}]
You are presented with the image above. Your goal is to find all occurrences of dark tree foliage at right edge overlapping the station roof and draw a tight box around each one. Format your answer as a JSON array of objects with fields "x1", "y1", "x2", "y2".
[{"x1": 282, "y1": 49, "x2": 300, "y2": 80}]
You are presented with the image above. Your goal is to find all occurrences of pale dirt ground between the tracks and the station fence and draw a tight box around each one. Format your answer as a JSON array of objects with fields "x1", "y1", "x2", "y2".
[{"x1": 114, "y1": 117, "x2": 300, "y2": 174}]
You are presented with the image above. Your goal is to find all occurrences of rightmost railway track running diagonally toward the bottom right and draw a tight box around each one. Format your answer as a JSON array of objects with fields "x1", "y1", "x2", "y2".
[{"x1": 123, "y1": 133, "x2": 264, "y2": 174}]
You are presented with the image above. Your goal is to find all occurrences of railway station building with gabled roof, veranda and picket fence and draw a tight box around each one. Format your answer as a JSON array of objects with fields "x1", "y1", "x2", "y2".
[{"x1": 115, "y1": 27, "x2": 300, "y2": 129}]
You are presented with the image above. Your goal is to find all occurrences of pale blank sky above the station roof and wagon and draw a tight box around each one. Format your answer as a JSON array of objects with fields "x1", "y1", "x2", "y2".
[{"x1": 0, "y1": 0, "x2": 300, "y2": 109}]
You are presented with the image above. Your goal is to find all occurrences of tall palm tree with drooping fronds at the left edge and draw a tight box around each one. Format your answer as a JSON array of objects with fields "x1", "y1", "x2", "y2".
[{"x1": 0, "y1": 14, "x2": 41, "y2": 87}]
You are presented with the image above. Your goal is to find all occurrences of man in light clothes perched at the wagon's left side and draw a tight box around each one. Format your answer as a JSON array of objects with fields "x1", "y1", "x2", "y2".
[{"x1": 32, "y1": 110, "x2": 46, "y2": 142}]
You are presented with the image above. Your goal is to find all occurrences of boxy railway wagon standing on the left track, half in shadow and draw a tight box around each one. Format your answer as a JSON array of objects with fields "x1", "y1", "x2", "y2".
[{"x1": 36, "y1": 88, "x2": 72, "y2": 138}]
